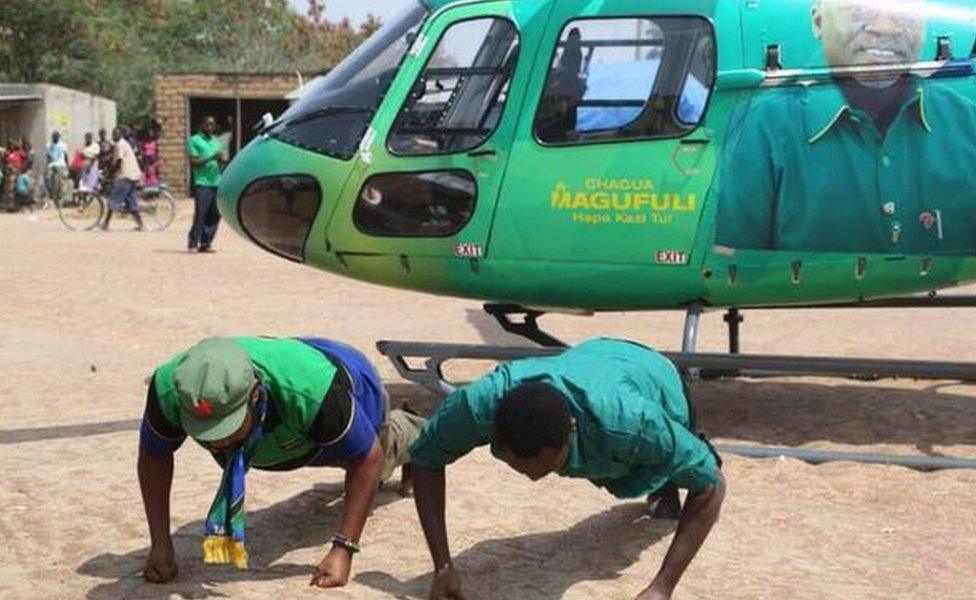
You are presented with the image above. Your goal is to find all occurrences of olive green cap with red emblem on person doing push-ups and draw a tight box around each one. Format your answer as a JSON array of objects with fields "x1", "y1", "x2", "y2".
[{"x1": 173, "y1": 338, "x2": 257, "y2": 442}]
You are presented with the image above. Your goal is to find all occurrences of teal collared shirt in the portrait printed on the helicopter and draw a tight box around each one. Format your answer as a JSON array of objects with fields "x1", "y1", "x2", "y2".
[{"x1": 716, "y1": 80, "x2": 976, "y2": 254}]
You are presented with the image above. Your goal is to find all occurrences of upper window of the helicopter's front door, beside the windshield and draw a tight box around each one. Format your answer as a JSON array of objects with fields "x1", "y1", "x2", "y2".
[{"x1": 388, "y1": 18, "x2": 519, "y2": 156}]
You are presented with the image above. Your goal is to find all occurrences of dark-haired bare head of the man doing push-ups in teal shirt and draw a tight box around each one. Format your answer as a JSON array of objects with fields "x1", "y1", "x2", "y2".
[{"x1": 495, "y1": 383, "x2": 575, "y2": 481}]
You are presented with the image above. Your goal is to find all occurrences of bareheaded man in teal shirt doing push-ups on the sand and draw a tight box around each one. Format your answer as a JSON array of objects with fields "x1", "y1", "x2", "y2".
[{"x1": 410, "y1": 339, "x2": 725, "y2": 600}]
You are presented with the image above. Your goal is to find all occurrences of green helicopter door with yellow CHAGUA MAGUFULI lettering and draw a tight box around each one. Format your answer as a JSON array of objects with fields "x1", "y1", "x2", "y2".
[{"x1": 491, "y1": 7, "x2": 716, "y2": 265}]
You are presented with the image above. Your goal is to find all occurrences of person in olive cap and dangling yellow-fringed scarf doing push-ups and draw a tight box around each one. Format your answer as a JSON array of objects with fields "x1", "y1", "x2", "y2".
[{"x1": 138, "y1": 337, "x2": 423, "y2": 587}]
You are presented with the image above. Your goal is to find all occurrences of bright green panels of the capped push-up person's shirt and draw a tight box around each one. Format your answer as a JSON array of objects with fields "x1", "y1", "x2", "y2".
[{"x1": 147, "y1": 337, "x2": 338, "y2": 469}]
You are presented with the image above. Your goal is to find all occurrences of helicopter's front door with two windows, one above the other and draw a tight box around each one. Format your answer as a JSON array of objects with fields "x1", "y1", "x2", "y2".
[{"x1": 329, "y1": 0, "x2": 547, "y2": 258}]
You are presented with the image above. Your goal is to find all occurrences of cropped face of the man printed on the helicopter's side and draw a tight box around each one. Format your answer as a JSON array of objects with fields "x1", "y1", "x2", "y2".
[{"x1": 813, "y1": 0, "x2": 925, "y2": 67}]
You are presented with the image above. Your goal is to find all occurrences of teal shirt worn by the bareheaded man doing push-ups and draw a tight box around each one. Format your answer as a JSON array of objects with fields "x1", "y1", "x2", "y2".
[{"x1": 410, "y1": 339, "x2": 718, "y2": 498}]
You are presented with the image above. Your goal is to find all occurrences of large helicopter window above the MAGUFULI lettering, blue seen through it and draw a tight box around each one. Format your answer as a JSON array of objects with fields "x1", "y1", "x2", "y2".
[{"x1": 535, "y1": 17, "x2": 715, "y2": 144}]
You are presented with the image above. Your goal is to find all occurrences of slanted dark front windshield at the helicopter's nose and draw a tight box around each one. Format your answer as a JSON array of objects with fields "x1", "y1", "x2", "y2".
[{"x1": 268, "y1": 0, "x2": 428, "y2": 160}]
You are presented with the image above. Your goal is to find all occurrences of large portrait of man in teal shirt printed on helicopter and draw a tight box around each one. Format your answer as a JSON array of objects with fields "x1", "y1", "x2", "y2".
[{"x1": 716, "y1": 0, "x2": 976, "y2": 255}]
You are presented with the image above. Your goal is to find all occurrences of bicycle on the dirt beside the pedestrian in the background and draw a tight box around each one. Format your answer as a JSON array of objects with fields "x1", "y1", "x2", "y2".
[{"x1": 58, "y1": 183, "x2": 176, "y2": 231}]
